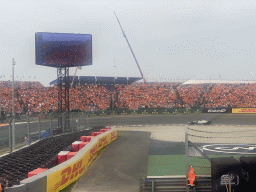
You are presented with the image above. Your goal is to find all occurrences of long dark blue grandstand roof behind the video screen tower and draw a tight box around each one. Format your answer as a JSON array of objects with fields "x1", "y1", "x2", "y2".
[{"x1": 50, "y1": 76, "x2": 142, "y2": 85}]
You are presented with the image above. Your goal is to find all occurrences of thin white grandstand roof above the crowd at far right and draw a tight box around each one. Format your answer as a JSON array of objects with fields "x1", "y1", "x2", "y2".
[{"x1": 182, "y1": 80, "x2": 256, "y2": 85}]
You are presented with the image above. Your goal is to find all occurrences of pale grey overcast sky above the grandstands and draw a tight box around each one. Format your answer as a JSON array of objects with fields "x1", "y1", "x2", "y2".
[{"x1": 0, "y1": 0, "x2": 256, "y2": 86}]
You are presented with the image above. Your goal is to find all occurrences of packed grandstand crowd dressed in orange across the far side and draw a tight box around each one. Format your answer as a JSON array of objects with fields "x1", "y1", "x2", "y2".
[{"x1": 0, "y1": 81, "x2": 256, "y2": 113}]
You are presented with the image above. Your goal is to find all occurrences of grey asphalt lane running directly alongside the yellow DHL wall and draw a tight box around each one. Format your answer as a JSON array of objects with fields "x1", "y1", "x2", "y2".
[{"x1": 71, "y1": 131, "x2": 150, "y2": 192}]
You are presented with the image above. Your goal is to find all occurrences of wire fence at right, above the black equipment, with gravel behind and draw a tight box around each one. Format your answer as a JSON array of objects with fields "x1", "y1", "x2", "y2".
[{"x1": 185, "y1": 125, "x2": 256, "y2": 175}]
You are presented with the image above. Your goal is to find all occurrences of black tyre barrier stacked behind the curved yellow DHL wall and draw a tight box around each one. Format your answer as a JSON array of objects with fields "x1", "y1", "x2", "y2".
[{"x1": 0, "y1": 127, "x2": 103, "y2": 189}]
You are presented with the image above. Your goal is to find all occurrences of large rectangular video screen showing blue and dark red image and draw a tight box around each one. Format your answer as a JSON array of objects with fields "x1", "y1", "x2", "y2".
[{"x1": 35, "y1": 32, "x2": 92, "y2": 67}]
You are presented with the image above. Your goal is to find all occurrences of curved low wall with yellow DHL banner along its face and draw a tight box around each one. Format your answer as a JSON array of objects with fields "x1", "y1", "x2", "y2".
[{"x1": 5, "y1": 129, "x2": 117, "y2": 192}]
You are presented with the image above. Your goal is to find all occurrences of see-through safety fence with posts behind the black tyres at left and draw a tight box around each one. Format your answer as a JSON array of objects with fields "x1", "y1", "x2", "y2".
[{"x1": 0, "y1": 112, "x2": 90, "y2": 155}]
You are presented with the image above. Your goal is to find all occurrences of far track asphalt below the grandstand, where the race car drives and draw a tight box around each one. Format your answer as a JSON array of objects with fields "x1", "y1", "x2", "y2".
[{"x1": 0, "y1": 113, "x2": 256, "y2": 139}]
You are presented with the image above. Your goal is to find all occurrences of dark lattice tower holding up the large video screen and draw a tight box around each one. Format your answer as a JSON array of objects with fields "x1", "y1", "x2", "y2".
[{"x1": 57, "y1": 67, "x2": 69, "y2": 133}]
